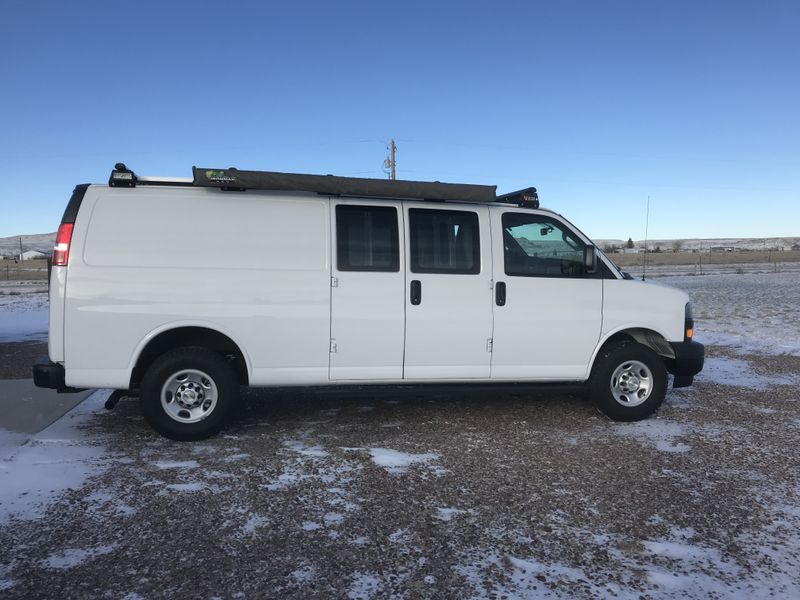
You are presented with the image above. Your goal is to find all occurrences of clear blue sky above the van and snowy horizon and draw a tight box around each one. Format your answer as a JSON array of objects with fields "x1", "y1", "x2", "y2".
[{"x1": 0, "y1": 0, "x2": 800, "y2": 239}]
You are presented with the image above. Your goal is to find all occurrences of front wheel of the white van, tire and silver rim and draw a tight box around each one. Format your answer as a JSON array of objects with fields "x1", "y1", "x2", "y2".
[{"x1": 589, "y1": 340, "x2": 667, "y2": 421}]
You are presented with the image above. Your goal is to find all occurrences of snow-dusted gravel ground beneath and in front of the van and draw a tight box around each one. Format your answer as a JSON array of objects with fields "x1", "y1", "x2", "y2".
[{"x1": 0, "y1": 273, "x2": 800, "y2": 599}]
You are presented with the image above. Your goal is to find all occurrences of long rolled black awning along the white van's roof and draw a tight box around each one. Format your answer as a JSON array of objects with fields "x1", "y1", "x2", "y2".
[{"x1": 192, "y1": 167, "x2": 497, "y2": 202}]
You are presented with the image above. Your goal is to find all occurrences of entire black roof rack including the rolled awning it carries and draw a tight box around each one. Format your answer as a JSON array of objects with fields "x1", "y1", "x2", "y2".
[{"x1": 108, "y1": 163, "x2": 539, "y2": 208}]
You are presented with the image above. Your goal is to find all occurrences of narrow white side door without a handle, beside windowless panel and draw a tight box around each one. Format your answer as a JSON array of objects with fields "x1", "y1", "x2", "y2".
[{"x1": 329, "y1": 200, "x2": 406, "y2": 380}]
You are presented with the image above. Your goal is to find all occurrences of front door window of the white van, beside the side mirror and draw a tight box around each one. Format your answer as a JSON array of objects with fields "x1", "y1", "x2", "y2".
[{"x1": 503, "y1": 213, "x2": 586, "y2": 277}]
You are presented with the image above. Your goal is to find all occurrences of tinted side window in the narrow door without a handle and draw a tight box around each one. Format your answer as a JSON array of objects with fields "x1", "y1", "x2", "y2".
[{"x1": 336, "y1": 204, "x2": 400, "y2": 271}]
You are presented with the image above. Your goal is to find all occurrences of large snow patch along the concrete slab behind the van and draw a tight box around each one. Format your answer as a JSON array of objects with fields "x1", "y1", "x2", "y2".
[{"x1": 0, "y1": 390, "x2": 114, "y2": 525}]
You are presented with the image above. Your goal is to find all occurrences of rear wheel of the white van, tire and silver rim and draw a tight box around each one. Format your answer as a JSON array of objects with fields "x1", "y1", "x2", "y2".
[{"x1": 140, "y1": 347, "x2": 239, "y2": 441}]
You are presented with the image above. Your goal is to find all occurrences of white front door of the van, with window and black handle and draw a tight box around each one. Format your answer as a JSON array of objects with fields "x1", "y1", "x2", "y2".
[{"x1": 491, "y1": 207, "x2": 603, "y2": 380}]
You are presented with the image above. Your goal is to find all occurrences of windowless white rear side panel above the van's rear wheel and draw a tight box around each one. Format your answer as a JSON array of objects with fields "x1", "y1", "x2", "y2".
[{"x1": 65, "y1": 186, "x2": 330, "y2": 388}]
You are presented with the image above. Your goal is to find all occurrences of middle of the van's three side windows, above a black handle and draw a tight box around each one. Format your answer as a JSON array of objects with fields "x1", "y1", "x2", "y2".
[{"x1": 408, "y1": 208, "x2": 481, "y2": 274}]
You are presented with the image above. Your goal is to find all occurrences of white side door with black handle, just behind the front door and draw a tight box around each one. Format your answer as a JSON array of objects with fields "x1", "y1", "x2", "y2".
[{"x1": 403, "y1": 202, "x2": 492, "y2": 379}]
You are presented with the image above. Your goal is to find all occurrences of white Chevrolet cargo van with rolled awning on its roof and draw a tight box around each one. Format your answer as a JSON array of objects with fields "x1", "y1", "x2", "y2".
[{"x1": 34, "y1": 163, "x2": 704, "y2": 440}]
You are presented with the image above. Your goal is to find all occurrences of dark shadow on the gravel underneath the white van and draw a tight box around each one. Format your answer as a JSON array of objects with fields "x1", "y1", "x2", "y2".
[{"x1": 101, "y1": 387, "x2": 602, "y2": 436}]
